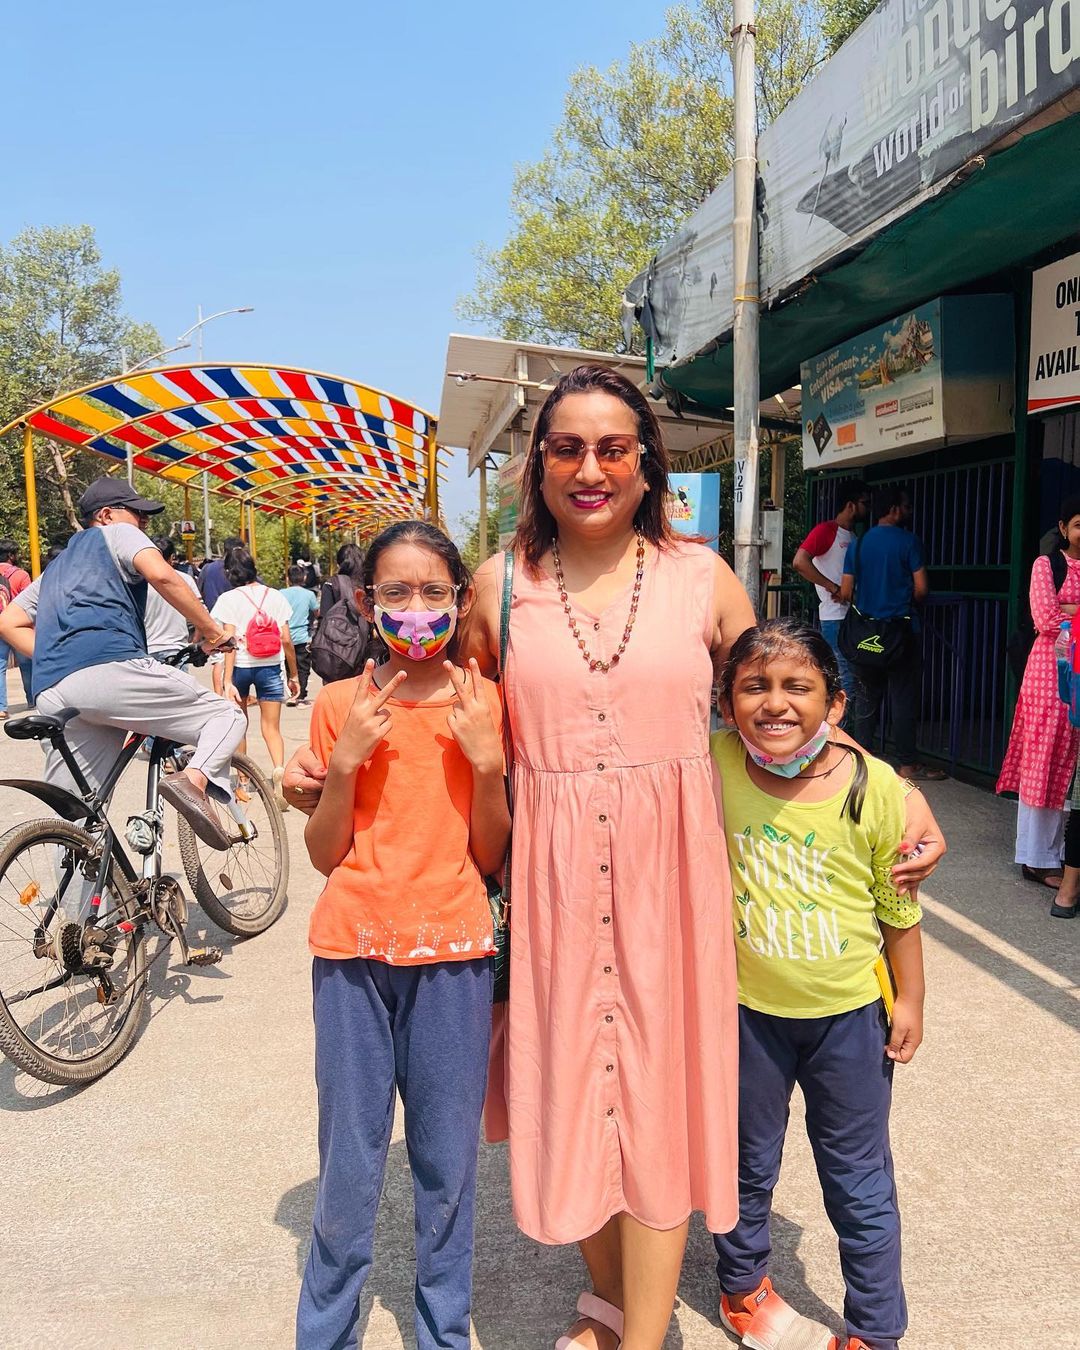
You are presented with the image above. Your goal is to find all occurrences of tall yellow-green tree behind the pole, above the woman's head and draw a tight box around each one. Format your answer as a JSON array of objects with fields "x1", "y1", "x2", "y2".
[{"x1": 460, "y1": 0, "x2": 826, "y2": 351}]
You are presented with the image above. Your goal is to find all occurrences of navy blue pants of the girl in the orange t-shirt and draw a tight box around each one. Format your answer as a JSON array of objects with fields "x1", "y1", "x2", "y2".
[{"x1": 296, "y1": 957, "x2": 493, "y2": 1350}]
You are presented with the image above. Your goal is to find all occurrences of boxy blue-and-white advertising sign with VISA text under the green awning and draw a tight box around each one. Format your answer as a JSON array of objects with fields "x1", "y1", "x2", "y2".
[{"x1": 802, "y1": 296, "x2": 1014, "y2": 470}]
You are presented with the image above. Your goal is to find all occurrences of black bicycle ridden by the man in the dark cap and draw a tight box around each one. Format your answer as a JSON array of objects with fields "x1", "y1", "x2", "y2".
[{"x1": 0, "y1": 647, "x2": 289, "y2": 1084}]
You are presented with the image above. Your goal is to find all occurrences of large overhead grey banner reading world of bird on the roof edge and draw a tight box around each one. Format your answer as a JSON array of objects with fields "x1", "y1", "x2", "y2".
[{"x1": 624, "y1": 0, "x2": 1080, "y2": 366}]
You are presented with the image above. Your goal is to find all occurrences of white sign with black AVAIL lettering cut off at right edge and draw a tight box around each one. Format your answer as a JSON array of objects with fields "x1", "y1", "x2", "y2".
[{"x1": 1027, "y1": 254, "x2": 1080, "y2": 413}]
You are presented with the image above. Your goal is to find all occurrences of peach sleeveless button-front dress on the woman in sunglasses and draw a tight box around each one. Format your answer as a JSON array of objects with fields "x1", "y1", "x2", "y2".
[{"x1": 489, "y1": 544, "x2": 738, "y2": 1243}]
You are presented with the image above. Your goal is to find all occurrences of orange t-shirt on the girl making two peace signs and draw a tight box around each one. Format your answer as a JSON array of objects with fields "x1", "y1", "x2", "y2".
[{"x1": 308, "y1": 679, "x2": 502, "y2": 965}]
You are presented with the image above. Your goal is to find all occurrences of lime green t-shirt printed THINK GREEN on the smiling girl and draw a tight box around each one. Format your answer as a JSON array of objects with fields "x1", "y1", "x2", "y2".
[{"x1": 711, "y1": 732, "x2": 922, "y2": 1018}]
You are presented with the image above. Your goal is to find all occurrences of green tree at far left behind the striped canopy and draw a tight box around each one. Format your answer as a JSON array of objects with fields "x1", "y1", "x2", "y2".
[{"x1": 0, "y1": 225, "x2": 161, "y2": 541}]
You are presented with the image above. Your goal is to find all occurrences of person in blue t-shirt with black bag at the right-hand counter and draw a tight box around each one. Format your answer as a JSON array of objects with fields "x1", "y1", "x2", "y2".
[{"x1": 840, "y1": 483, "x2": 945, "y2": 779}]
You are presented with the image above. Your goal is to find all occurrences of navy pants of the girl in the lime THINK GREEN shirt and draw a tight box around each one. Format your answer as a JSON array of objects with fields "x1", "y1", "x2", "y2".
[{"x1": 714, "y1": 1003, "x2": 907, "y2": 1350}]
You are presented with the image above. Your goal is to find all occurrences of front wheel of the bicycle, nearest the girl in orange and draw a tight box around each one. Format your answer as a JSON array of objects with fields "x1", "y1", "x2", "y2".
[{"x1": 180, "y1": 755, "x2": 289, "y2": 937}]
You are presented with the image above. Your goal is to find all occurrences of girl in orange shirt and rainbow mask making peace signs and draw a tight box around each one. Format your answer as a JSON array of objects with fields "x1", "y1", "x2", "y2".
[{"x1": 297, "y1": 521, "x2": 510, "y2": 1350}]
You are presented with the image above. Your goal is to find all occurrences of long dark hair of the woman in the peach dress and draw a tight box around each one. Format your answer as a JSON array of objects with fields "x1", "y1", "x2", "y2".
[{"x1": 513, "y1": 366, "x2": 675, "y2": 568}]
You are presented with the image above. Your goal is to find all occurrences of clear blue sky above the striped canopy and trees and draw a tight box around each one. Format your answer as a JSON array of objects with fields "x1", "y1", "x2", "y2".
[{"x1": 0, "y1": 0, "x2": 664, "y2": 537}]
